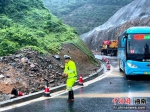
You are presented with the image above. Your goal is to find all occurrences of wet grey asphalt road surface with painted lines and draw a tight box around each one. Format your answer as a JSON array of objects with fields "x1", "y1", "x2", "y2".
[{"x1": 1, "y1": 55, "x2": 150, "y2": 112}]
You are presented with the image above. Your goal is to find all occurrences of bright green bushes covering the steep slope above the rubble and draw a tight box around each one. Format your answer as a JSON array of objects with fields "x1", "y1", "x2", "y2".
[{"x1": 0, "y1": 0, "x2": 98, "y2": 65}]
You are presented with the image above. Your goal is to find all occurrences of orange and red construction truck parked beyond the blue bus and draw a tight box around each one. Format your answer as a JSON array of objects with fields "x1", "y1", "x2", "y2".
[{"x1": 101, "y1": 40, "x2": 118, "y2": 56}]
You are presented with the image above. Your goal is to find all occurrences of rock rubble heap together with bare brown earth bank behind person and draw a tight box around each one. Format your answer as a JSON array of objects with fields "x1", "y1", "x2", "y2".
[{"x1": 0, "y1": 44, "x2": 99, "y2": 101}]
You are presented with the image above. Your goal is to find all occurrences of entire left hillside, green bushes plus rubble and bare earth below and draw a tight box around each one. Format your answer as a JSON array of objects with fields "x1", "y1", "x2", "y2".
[{"x1": 0, "y1": 0, "x2": 100, "y2": 101}]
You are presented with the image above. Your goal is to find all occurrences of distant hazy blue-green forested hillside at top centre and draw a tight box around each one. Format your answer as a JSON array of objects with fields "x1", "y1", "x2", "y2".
[{"x1": 44, "y1": 0, "x2": 133, "y2": 34}]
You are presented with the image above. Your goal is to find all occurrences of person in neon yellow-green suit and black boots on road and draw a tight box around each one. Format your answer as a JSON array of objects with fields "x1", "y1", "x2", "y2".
[{"x1": 62, "y1": 55, "x2": 77, "y2": 102}]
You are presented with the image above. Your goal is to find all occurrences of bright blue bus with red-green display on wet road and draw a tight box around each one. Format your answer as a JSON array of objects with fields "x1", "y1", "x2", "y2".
[{"x1": 117, "y1": 27, "x2": 150, "y2": 77}]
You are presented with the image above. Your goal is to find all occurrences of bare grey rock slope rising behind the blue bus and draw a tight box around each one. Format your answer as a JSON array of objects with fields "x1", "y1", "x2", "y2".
[{"x1": 80, "y1": 0, "x2": 150, "y2": 50}]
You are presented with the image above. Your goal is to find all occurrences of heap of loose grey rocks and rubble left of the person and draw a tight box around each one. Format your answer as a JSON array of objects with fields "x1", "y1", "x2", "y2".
[{"x1": 0, "y1": 49, "x2": 65, "y2": 93}]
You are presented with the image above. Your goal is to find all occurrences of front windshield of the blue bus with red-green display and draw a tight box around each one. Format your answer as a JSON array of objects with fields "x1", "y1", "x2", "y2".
[{"x1": 127, "y1": 34, "x2": 150, "y2": 56}]
